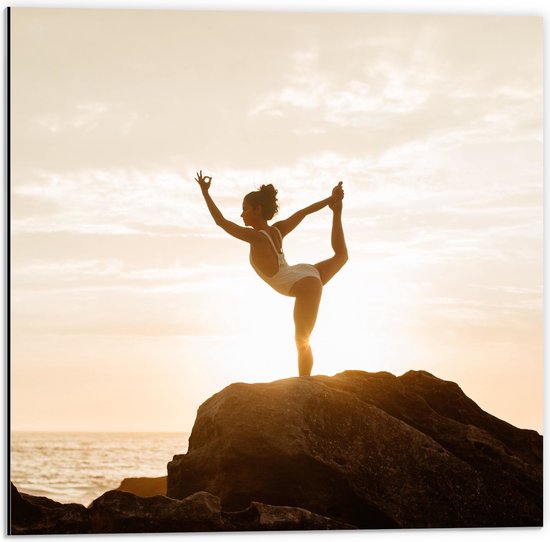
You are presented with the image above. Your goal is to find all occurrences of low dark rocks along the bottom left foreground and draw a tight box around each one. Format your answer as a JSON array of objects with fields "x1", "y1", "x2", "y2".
[{"x1": 10, "y1": 484, "x2": 353, "y2": 534}]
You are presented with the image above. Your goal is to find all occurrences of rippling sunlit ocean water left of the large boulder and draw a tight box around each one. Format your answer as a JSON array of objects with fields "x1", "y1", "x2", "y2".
[{"x1": 10, "y1": 432, "x2": 189, "y2": 506}]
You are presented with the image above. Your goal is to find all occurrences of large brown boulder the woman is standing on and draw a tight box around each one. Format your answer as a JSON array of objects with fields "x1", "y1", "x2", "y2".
[{"x1": 167, "y1": 371, "x2": 542, "y2": 528}]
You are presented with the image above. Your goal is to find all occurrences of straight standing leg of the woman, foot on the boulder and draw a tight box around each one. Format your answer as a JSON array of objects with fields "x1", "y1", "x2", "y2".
[{"x1": 293, "y1": 277, "x2": 323, "y2": 376}]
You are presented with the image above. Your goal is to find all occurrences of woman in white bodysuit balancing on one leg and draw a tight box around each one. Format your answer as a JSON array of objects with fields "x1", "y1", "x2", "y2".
[{"x1": 195, "y1": 170, "x2": 348, "y2": 376}]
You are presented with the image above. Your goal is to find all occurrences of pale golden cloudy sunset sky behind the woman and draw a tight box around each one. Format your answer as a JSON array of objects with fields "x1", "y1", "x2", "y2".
[{"x1": 10, "y1": 8, "x2": 543, "y2": 432}]
